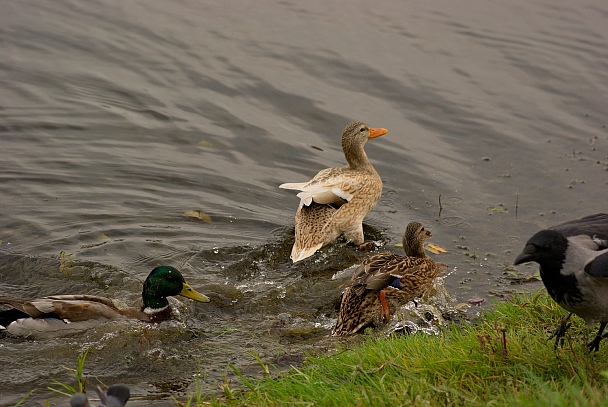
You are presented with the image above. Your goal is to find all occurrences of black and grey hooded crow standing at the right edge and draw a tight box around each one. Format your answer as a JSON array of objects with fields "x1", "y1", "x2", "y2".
[{"x1": 514, "y1": 213, "x2": 608, "y2": 351}]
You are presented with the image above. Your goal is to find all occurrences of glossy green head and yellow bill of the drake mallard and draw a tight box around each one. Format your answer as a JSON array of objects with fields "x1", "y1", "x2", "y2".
[{"x1": 142, "y1": 266, "x2": 209, "y2": 310}]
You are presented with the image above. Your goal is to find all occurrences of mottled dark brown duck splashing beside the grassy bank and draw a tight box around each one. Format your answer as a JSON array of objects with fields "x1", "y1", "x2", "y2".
[{"x1": 332, "y1": 222, "x2": 447, "y2": 336}]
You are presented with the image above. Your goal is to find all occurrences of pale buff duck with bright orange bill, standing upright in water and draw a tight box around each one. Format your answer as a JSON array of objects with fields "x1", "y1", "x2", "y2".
[{"x1": 279, "y1": 122, "x2": 388, "y2": 263}]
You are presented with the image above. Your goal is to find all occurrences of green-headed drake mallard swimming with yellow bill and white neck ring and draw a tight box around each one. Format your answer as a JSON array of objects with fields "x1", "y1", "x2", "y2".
[{"x1": 0, "y1": 266, "x2": 209, "y2": 337}]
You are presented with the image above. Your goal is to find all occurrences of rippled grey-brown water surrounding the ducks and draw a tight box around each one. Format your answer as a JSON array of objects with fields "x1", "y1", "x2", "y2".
[{"x1": 0, "y1": 0, "x2": 608, "y2": 405}]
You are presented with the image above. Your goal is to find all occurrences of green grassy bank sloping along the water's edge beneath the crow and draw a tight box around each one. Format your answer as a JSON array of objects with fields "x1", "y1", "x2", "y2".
[{"x1": 211, "y1": 291, "x2": 608, "y2": 406}]
